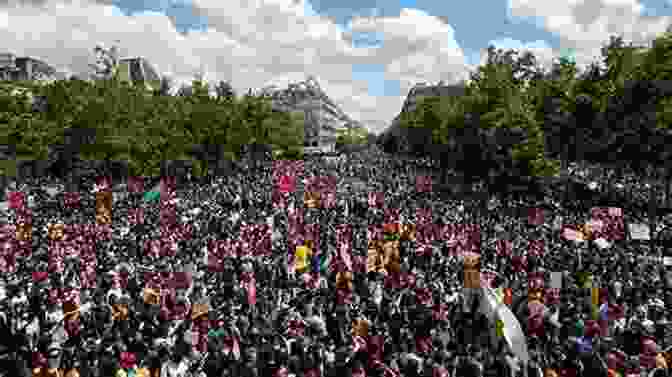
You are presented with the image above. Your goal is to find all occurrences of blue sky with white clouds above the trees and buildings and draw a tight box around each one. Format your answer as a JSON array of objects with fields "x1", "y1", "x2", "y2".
[{"x1": 0, "y1": 0, "x2": 672, "y2": 133}]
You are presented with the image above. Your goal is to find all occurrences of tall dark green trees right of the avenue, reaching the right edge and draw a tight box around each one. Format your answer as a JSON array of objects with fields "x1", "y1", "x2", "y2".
[{"x1": 379, "y1": 33, "x2": 672, "y2": 198}]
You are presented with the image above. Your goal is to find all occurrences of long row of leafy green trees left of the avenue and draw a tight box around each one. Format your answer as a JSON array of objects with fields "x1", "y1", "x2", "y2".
[{"x1": 0, "y1": 75, "x2": 304, "y2": 176}]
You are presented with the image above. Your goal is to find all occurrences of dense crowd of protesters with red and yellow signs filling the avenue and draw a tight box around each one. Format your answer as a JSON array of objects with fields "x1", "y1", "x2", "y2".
[{"x1": 0, "y1": 150, "x2": 672, "y2": 377}]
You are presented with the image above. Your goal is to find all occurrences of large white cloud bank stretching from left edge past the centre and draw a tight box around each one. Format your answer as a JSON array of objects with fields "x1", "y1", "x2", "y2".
[{"x1": 0, "y1": 0, "x2": 476, "y2": 132}]
